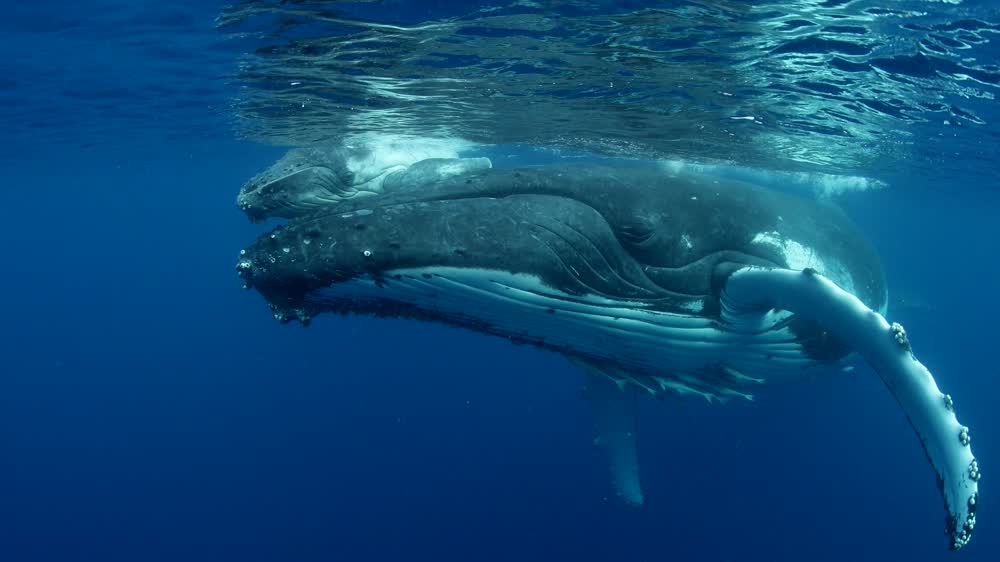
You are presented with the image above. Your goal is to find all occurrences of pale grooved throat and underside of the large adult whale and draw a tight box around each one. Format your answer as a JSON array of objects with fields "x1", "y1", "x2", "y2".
[{"x1": 302, "y1": 267, "x2": 846, "y2": 401}]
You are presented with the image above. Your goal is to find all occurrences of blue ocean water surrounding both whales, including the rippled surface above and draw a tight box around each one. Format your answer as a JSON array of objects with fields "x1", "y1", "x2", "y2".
[{"x1": 0, "y1": 0, "x2": 1000, "y2": 562}]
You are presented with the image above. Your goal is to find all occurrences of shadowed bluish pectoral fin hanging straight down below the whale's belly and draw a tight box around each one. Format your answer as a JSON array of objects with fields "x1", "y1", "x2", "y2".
[{"x1": 574, "y1": 360, "x2": 642, "y2": 505}]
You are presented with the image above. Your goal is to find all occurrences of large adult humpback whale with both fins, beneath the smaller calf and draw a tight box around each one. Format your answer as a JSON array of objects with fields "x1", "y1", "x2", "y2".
[{"x1": 237, "y1": 163, "x2": 979, "y2": 550}]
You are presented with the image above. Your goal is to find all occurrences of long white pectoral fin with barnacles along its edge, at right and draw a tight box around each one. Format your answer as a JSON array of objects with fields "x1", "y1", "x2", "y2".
[{"x1": 721, "y1": 267, "x2": 979, "y2": 550}]
